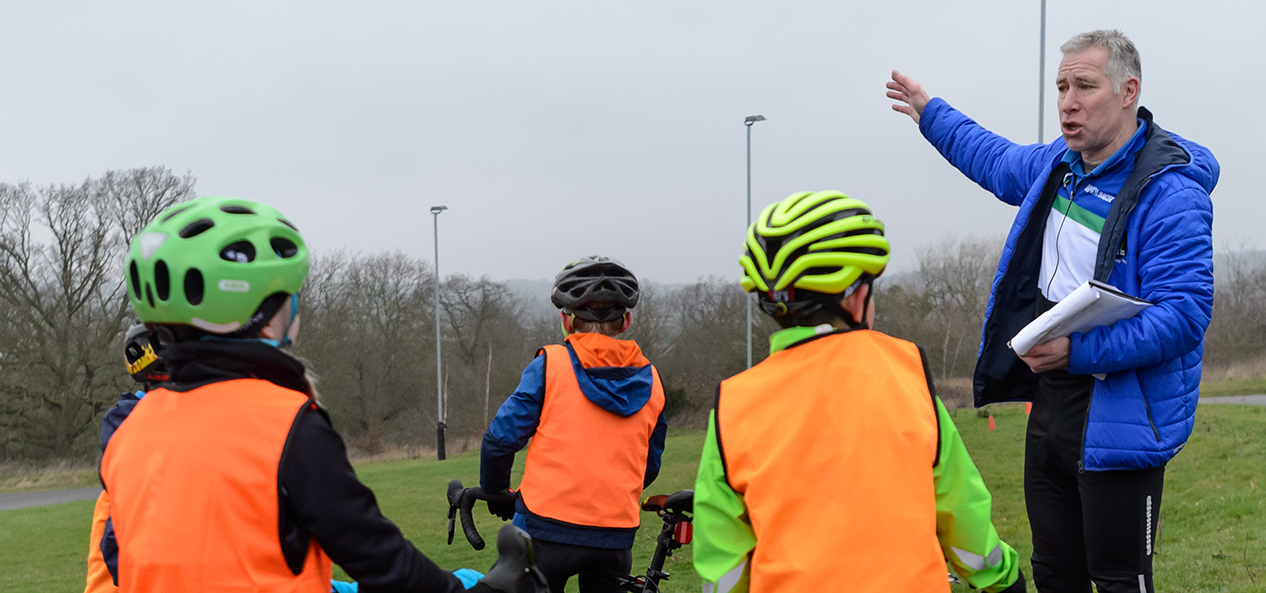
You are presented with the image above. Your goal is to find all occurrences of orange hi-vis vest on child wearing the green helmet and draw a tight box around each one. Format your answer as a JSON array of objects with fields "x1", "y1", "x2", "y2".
[{"x1": 101, "y1": 379, "x2": 332, "y2": 593}]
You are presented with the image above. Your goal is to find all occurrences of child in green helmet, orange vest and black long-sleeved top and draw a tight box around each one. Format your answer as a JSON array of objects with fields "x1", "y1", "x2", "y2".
[{"x1": 101, "y1": 198, "x2": 513, "y2": 593}]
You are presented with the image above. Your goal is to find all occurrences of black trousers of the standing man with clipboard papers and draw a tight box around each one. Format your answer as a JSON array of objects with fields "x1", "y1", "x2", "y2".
[{"x1": 1024, "y1": 371, "x2": 1165, "y2": 593}]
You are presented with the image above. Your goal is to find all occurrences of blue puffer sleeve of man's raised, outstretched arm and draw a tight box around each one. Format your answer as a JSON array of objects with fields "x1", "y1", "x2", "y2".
[{"x1": 919, "y1": 98, "x2": 1066, "y2": 205}]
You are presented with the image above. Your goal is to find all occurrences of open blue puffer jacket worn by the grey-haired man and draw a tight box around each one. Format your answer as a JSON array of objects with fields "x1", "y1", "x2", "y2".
[{"x1": 919, "y1": 99, "x2": 1219, "y2": 470}]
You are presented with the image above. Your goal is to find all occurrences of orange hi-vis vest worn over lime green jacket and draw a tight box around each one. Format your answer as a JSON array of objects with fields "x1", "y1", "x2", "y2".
[{"x1": 715, "y1": 329, "x2": 950, "y2": 593}]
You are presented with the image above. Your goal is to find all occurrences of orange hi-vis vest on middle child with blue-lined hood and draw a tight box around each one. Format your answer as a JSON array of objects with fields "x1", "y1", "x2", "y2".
[{"x1": 519, "y1": 333, "x2": 663, "y2": 530}]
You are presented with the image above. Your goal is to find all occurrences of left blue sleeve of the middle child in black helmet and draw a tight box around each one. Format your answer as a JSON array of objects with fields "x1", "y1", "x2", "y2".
[{"x1": 479, "y1": 356, "x2": 546, "y2": 492}]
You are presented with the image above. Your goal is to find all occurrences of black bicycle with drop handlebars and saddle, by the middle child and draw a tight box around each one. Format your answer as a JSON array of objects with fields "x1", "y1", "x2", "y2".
[{"x1": 448, "y1": 480, "x2": 695, "y2": 593}]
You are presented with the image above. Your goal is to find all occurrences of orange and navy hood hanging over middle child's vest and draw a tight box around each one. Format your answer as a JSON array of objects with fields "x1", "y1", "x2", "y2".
[{"x1": 567, "y1": 333, "x2": 655, "y2": 417}]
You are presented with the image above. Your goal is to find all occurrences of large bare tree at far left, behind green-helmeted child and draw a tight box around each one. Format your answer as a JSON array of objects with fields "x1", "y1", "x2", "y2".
[{"x1": 0, "y1": 167, "x2": 194, "y2": 457}]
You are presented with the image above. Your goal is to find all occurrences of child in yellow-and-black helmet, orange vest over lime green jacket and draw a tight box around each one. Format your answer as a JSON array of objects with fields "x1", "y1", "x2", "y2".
[{"x1": 694, "y1": 191, "x2": 1024, "y2": 593}]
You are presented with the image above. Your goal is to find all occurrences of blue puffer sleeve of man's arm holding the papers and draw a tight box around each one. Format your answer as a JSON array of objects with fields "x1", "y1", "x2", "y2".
[{"x1": 1069, "y1": 181, "x2": 1213, "y2": 375}]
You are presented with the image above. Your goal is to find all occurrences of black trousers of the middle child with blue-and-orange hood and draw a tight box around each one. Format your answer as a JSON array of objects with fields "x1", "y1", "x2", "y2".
[{"x1": 532, "y1": 540, "x2": 633, "y2": 593}]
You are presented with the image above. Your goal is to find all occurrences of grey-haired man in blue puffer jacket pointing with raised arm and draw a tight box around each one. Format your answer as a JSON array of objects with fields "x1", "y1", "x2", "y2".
[{"x1": 887, "y1": 30, "x2": 1218, "y2": 593}]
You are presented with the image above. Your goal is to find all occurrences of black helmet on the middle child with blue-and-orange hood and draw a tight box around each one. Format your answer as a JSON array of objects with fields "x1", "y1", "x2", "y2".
[{"x1": 549, "y1": 255, "x2": 639, "y2": 322}]
